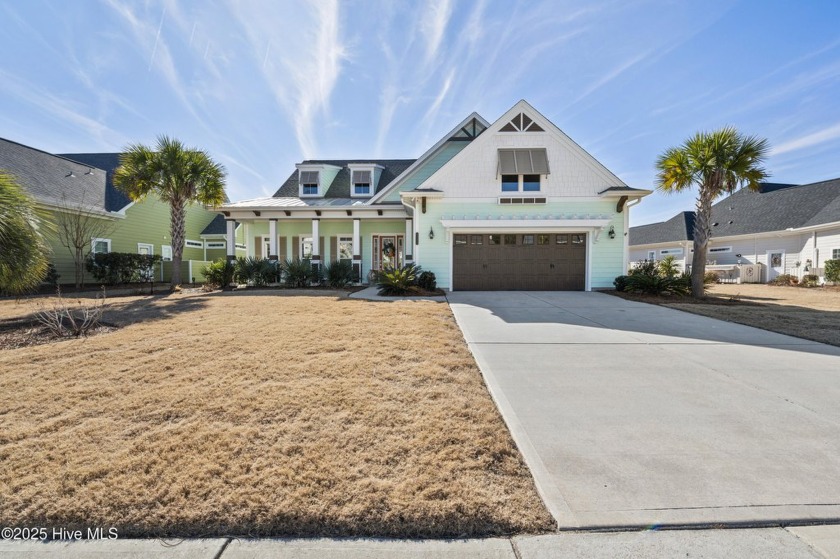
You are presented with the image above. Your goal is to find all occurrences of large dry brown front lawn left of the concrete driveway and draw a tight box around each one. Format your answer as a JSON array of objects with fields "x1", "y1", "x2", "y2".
[{"x1": 0, "y1": 292, "x2": 552, "y2": 537}]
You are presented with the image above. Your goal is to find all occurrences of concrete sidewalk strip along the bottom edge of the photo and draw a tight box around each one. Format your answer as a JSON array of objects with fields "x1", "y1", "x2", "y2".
[{"x1": 0, "y1": 526, "x2": 840, "y2": 559}]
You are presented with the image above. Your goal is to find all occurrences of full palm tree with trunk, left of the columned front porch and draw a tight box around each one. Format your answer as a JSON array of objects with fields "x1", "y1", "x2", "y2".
[{"x1": 114, "y1": 136, "x2": 226, "y2": 290}]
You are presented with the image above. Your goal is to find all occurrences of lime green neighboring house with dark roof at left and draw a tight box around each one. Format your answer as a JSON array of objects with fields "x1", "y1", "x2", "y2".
[{"x1": 0, "y1": 138, "x2": 226, "y2": 284}]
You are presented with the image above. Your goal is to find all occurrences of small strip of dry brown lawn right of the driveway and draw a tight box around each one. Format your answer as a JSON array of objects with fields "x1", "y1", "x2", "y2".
[{"x1": 612, "y1": 284, "x2": 840, "y2": 346}]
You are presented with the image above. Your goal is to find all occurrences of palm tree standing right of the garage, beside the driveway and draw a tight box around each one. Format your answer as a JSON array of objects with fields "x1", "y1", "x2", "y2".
[{"x1": 656, "y1": 127, "x2": 768, "y2": 297}]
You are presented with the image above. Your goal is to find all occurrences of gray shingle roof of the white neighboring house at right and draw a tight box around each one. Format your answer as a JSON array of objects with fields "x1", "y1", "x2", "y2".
[{"x1": 630, "y1": 178, "x2": 840, "y2": 245}]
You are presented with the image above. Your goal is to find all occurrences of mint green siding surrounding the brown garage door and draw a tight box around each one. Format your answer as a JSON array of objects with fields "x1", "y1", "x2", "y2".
[{"x1": 416, "y1": 200, "x2": 624, "y2": 289}]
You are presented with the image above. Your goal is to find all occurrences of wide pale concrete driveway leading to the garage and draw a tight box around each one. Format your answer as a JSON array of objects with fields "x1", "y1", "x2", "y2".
[{"x1": 449, "y1": 292, "x2": 840, "y2": 528}]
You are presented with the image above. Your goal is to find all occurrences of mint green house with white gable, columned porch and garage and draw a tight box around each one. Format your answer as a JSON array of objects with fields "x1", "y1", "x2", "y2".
[{"x1": 218, "y1": 101, "x2": 650, "y2": 290}]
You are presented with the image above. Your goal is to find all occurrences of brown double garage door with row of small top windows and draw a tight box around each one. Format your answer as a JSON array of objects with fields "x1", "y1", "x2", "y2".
[{"x1": 452, "y1": 233, "x2": 586, "y2": 291}]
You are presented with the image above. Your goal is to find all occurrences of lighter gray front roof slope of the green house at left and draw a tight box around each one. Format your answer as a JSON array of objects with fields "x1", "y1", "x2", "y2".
[{"x1": 0, "y1": 138, "x2": 108, "y2": 210}]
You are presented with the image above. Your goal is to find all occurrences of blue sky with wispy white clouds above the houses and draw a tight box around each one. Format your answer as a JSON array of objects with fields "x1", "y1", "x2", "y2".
[{"x1": 0, "y1": 0, "x2": 840, "y2": 224}]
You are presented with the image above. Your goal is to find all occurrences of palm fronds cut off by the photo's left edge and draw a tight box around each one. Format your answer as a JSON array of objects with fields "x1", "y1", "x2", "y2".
[{"x1": 0, "y1": 171, "x2": 49, "y2": 295}]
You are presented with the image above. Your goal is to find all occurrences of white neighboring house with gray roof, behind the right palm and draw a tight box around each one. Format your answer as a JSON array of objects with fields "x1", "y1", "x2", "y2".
[{"x1": 630, "y1": 179, "x2": 840, "y2": 281}]
